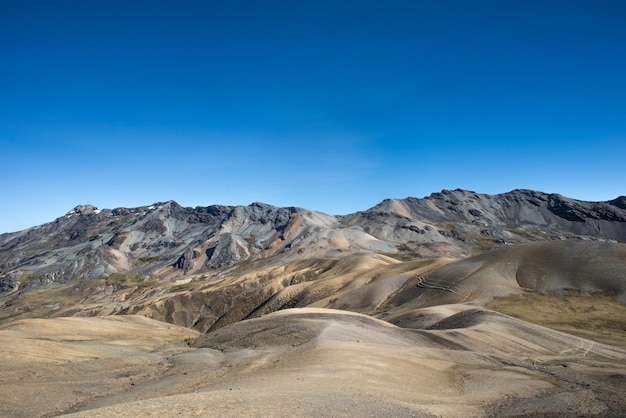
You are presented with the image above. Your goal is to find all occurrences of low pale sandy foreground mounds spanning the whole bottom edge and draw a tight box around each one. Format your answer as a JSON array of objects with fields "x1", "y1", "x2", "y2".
[{"x1": 0, "y1": 305, "x2": 626, "y2": 417}]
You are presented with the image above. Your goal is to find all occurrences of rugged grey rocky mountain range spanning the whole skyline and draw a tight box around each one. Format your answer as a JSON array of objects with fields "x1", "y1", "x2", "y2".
[{"x1": 0, "y1": 190, "x2": 626, "y2": 294}]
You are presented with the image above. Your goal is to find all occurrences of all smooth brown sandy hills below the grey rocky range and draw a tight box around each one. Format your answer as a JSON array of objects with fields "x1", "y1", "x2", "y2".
[{"x1": 0, "y1": 242, "x2": 626, "y2": 417}]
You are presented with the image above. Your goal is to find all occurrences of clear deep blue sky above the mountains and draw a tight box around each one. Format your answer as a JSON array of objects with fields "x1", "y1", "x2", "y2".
[{"x1": 0, "y1": 0, "x2": 626, "y2": 232}]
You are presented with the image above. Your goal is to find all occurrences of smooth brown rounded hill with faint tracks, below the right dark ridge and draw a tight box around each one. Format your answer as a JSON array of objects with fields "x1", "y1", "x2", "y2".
[{"x1": 376, "y1": 240, "x2": 626, "y2": 314}]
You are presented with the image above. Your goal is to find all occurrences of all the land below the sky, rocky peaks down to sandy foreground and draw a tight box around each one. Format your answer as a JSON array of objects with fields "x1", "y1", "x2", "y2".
[{"x1": 0, "y1": 190, "x2": 626, "y2": 417}]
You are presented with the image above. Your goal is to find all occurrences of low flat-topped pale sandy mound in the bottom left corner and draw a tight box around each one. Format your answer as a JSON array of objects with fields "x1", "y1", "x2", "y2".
[{"x1": 0, "y1": 316, "x2": 197, "y2": 417}]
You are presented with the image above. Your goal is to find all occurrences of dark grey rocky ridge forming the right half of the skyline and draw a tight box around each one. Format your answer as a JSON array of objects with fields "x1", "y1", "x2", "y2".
[{"x1": 342, "y1": 190, "x2": 626, "y2": 256}]
